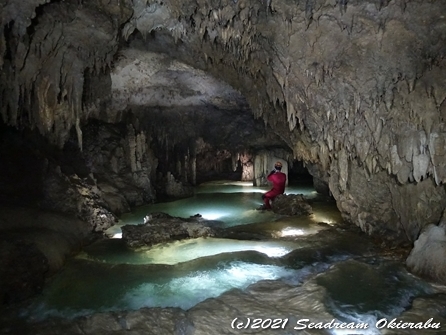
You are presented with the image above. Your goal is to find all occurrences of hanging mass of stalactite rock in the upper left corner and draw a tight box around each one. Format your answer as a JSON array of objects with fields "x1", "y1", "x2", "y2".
[{"x1": 0, "y1": 0, "x2": 132, "y2": 146}]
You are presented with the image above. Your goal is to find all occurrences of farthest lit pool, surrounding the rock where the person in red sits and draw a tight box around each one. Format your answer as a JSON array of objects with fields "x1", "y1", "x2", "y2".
[{"x1": 114, "y1": 182, "x2": 341, "y2": 231}]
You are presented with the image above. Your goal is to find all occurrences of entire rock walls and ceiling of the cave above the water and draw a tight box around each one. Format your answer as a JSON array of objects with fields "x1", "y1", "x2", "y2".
[{"x1": 0, "y1": 0, "x2": 446, "y2": 288}]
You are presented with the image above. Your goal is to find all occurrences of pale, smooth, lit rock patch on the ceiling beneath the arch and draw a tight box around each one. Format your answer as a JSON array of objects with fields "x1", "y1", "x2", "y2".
[{"x1": 108, "y1": 48, "x2": 249, "y2": 113}]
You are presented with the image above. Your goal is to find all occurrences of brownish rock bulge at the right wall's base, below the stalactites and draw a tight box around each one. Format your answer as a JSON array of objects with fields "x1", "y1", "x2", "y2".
[{"x1": 329, "y1": 163, "x2": 446, "y2": 241}]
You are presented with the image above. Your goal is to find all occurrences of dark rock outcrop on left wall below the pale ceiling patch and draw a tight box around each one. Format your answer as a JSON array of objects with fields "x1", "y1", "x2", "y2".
[{"x1": 80, "y1": 118, "x2": 158, "y2": 214}]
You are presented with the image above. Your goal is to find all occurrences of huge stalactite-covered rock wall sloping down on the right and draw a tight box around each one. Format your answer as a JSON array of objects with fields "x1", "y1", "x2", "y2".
[{"x1": 119, "y1": 0, "x2": 446, "y2": 240}]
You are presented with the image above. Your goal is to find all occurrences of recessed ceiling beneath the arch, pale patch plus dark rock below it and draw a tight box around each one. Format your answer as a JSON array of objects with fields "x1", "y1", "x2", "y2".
[{"x1": 106, "y1": 36, "x2": 290, "y2": 154}]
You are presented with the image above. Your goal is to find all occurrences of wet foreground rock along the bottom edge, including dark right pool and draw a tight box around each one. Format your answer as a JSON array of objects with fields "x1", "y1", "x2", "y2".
[{"x1": 1, "y1": 259, "x2": 445, "y2": 335}]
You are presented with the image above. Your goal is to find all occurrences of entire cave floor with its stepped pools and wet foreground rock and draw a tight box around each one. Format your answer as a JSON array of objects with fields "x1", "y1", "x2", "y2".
[{"x1": 2, "y1": 182, "x2": 446, "y2": 334}]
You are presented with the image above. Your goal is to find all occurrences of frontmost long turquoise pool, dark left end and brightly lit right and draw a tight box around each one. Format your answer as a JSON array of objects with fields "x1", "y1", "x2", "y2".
[{"x1": 27, "y1": 260, "x2": 295, "y2": 319}]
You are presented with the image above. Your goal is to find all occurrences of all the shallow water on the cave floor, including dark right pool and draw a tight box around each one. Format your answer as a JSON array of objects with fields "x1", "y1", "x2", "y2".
[{"x1": 15, "y1": 182, "x2": 443, "y2": 334}]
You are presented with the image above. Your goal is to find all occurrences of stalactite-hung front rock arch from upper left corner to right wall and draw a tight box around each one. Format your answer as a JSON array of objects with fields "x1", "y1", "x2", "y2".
[{"x1": 0, "y1": 0, "x2": 446, "y2": 244}]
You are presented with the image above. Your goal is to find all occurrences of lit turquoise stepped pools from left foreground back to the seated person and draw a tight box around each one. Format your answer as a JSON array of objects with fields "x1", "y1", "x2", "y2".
[{"x1": 24, "y1": 182, "x2": 340, "y2": 318}]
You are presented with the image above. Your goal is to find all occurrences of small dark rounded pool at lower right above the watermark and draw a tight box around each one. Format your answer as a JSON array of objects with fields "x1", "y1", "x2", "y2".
[{"x1": 316, "y1": 260, "x2": 434, "y2": 321}]
